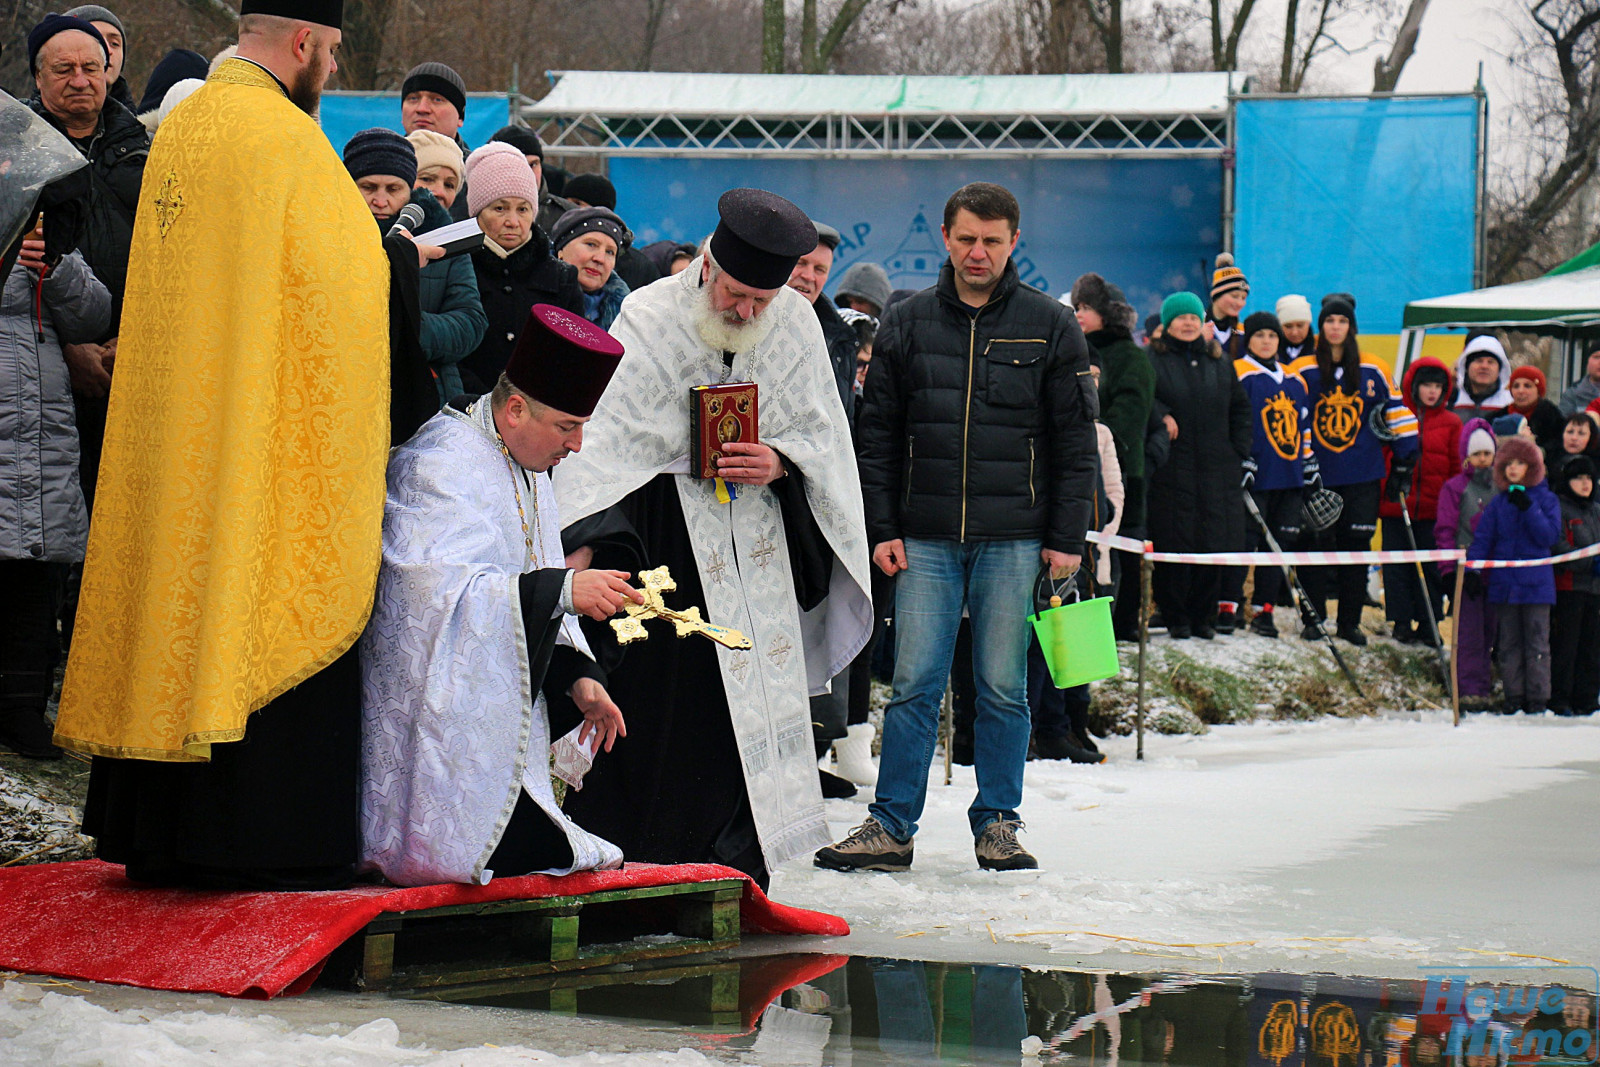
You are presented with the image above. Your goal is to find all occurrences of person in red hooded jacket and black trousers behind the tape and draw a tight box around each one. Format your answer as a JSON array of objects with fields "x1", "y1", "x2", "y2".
[{"x1": 1378, "y1": 355, "x2": 1461, "y2": 645}]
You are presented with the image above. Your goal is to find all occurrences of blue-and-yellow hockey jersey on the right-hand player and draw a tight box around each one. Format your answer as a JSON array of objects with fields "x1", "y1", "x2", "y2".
[{"x1": 1290, "y1": 352, "x2": 1418, "y2": 488}]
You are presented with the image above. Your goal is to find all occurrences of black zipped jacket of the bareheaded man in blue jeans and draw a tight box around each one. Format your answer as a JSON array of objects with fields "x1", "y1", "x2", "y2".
[{"x1": 858, "y1": 264, "x2": 1099, "y2": 553}]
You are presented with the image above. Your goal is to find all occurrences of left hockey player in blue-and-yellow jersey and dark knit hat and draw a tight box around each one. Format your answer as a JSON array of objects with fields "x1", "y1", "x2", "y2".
[{"x1": 1234, "y1": 312, "x2": 1317, "y2": 637}]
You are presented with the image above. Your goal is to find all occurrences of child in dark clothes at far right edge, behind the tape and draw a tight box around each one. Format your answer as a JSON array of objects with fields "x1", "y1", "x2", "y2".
[{"x1": 1550, "y1": 460, "x2": 1600, "y2": 715}]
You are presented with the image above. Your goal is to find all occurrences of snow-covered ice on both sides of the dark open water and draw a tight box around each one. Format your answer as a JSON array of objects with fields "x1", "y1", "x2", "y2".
[{"x1": 0, "y1": 713, "x2": 1600, "y2": 1067}]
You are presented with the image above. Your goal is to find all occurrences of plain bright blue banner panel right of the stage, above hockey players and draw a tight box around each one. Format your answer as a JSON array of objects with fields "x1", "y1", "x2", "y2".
[{"x1": 1234, "y1": 96, "x2": 1478, "y2": 334}]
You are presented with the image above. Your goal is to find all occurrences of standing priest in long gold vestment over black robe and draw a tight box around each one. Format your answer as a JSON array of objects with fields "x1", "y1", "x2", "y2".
[{"x1": 56, "y1": 0, "x2": 434, "y2": 889}]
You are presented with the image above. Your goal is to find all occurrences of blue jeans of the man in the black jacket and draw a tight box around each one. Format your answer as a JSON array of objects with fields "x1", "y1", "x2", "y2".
[{"x1": 869, "y1": 537, "x2": 1040, "y2": 841}]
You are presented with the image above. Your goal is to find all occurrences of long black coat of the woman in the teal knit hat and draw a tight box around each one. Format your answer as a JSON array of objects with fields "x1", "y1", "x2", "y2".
[{"x1": 1146, "y1": 336, "x2": 1251, "y2": 552}]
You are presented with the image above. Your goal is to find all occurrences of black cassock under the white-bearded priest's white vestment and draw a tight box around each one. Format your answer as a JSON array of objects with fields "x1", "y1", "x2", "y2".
[{"x1": 557, "y1": 472, "x2": 834, "y2": 888}]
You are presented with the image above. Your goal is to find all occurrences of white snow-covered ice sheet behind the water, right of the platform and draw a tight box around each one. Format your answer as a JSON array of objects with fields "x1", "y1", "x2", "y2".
[{"x1": 771, "y1": 713, "x2": 1600, "y2": 974}]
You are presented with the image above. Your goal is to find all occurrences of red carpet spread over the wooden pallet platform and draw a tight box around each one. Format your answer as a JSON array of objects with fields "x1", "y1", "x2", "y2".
[{"x1": 0, "y1": 859, "x2": 850, "y2": 997}]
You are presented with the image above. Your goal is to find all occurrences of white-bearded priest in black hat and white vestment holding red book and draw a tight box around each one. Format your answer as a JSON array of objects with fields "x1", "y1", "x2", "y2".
[{"x1": 555, "y1": 189, "x2": 872, "y2": 883}]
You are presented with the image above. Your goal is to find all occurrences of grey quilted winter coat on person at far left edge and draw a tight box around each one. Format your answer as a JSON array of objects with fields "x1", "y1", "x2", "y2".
[{"x1": 0, "y1": 253, "x2": 110, "y2": 563}]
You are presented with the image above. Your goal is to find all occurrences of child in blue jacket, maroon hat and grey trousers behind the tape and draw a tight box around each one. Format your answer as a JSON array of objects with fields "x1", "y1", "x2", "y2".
[{"x1": 1467, "y1": 437, "x2": 1562, "y2": 715}]
